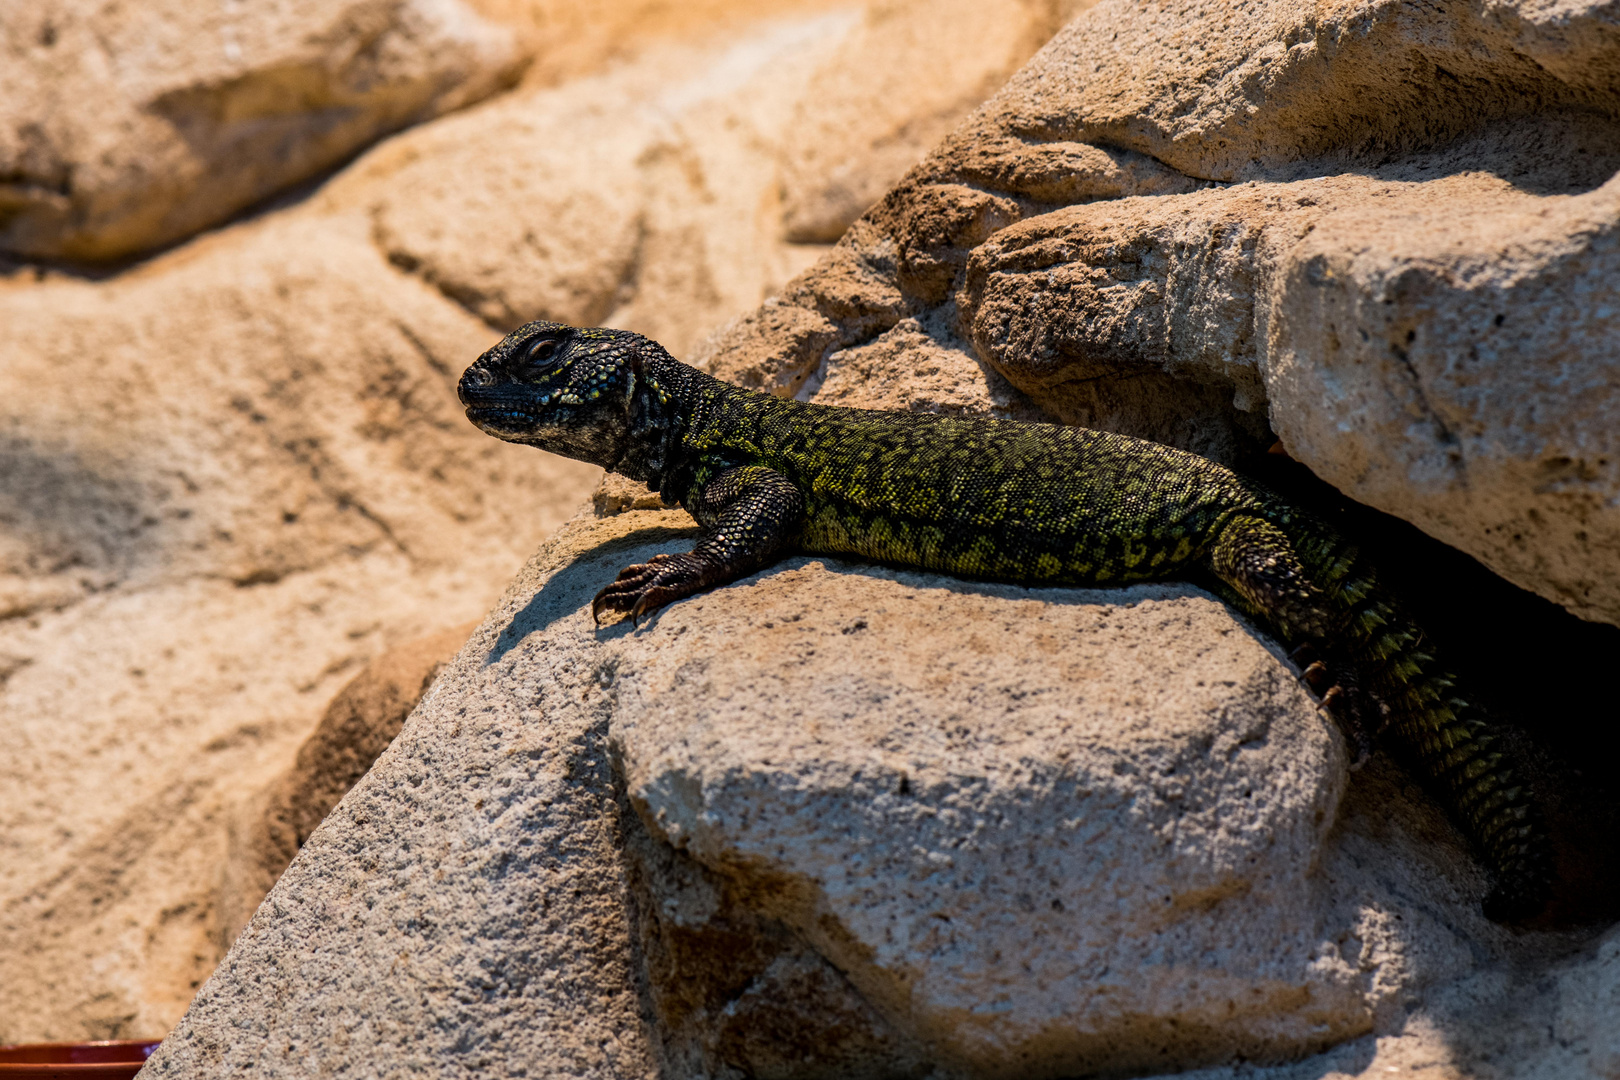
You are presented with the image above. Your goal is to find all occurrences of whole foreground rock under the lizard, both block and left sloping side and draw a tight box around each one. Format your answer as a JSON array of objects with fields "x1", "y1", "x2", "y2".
[{"x1": 146, "y1": 512, "x2": 1542, "y2": 1077}]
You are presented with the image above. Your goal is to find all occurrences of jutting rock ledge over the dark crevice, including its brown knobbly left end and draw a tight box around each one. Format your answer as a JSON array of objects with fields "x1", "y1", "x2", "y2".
[{"x1": 961, "y1": 118, "x2": 1620, "y2": 622}]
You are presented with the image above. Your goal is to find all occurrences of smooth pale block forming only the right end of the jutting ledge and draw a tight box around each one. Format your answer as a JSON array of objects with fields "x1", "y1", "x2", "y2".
[{"x1": 1265, "y1": 159, "x2": 1620, "y2": 623}]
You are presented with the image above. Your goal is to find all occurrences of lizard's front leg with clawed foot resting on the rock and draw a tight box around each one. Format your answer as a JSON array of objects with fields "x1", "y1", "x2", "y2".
[{"x1": 591, "y1": 465, "x2": 805, "y2": 623}]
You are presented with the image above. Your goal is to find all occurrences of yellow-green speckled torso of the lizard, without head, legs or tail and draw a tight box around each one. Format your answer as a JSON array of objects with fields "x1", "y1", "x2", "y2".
[{"x1": 684, "y1": 393, "x2": 1224, "y2": 585}]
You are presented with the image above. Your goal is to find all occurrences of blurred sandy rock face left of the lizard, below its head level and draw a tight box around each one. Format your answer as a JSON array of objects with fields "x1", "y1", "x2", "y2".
[{"x1": 0, "y1": 214, "x2": 598, "y2": 1041}]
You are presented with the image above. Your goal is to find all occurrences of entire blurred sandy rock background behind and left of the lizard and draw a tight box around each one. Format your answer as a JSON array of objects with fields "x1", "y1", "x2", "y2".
[{"x1": 0, "y1": 0, "x2": 1074, "y2": 1041}]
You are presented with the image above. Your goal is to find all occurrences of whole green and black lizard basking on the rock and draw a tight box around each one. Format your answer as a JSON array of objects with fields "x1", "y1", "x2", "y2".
[{"x1": 458, "y1": 322, "x2": 1550, "y2": 920}]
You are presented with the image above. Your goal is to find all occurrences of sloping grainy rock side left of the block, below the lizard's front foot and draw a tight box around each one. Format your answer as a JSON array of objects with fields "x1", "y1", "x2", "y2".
[{"x1": 136, "y1": 515, "x2": 686, "y2": 1077}]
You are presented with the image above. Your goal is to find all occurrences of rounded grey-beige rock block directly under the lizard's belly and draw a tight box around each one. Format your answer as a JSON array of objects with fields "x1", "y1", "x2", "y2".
[{"x1": 609, "y1": 562, "x2": 1375, "y2": 1075}]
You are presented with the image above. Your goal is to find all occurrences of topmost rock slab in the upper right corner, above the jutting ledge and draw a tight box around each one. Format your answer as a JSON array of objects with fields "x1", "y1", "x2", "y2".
[{"x1": 991, "y1": 0, "x2": 1620, "y2": 180}]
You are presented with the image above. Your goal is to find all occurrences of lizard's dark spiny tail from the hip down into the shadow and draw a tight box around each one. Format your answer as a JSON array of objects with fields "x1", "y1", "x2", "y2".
[{"x1": 1209, "y1": 515, "x2": 1552, "y2": 921}]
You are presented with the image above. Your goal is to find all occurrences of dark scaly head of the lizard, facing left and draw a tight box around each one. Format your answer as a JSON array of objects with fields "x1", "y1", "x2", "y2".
[{"x1": 455, "y1": 322, "x2": 651, "y2": 470}]
